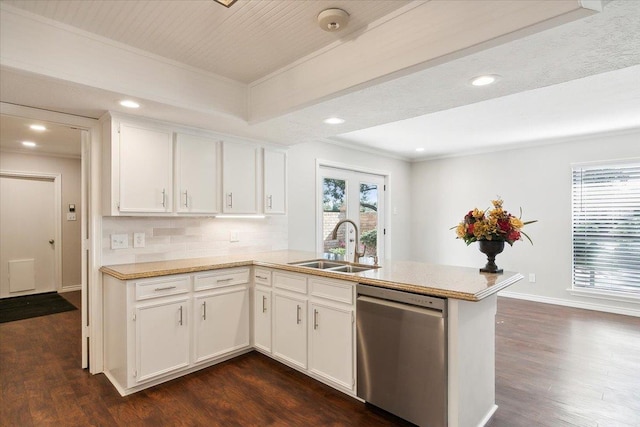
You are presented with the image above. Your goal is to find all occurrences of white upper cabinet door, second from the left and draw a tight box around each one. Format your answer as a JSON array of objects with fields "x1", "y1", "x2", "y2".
[{"x1": 175, "y1": 134, "x2": 218, "y2": 213}]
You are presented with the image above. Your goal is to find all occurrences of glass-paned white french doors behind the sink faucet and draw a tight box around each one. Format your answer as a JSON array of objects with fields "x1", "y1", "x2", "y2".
[{"x1": 317, "y1": 166, "x2": 385, "y2": 263}]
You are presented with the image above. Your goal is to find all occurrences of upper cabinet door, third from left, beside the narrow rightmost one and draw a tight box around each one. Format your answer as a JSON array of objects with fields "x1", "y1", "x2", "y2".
[{"x1": 222, "y1": 142, "x2": 258, "y2": 214}]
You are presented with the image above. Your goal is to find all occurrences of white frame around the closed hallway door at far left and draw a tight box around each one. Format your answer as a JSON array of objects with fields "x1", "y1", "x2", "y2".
[{"x1": 0, "y1": 170, "x2": 62, "y2": 292}]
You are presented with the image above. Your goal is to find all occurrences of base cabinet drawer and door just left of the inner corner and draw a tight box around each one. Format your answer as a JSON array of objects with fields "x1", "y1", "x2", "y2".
[{"x1": 193, "y1": 268, "x2": 250, "y2": 363}]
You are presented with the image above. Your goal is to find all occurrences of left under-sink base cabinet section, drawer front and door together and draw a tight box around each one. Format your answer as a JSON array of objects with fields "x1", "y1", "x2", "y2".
[{"x1": 273, "y1": 271, "x2": 307, "y2": 369}]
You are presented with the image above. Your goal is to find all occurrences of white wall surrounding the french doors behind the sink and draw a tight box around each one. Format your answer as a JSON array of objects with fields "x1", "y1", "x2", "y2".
[{"x1": 287, "y1": 142, "x2": 411, "y2": 259}]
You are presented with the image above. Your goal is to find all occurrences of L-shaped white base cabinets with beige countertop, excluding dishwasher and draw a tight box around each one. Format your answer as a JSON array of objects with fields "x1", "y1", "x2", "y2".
[{"x1": 101, "y1": 251, "x2": 522, "y2": 427}]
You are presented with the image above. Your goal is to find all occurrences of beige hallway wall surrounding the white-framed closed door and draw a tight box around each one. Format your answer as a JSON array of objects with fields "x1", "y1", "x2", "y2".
[{"x1": 0, "y1": 151, "x2": 82, "y2": 290}]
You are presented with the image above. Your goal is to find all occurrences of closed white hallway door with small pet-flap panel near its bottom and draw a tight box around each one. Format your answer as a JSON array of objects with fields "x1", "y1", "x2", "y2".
[{"x1": 0, "y1": 176, "x2": 60, "y2": 298}]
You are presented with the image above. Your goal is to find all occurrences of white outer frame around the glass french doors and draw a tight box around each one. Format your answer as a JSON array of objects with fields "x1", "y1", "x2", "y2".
[{"x1": 315, "y1": 159, "x2": 391, "y2": 259}]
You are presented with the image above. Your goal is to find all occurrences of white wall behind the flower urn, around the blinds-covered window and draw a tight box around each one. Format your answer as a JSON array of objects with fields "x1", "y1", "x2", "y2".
[{"x1": 411, "y1": 130, "x2": 640, "y2": 313}]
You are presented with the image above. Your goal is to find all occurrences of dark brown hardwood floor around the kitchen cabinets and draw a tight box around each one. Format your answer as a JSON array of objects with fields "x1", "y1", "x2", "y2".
[{"x1": 0, "y1": 293, "x2": 640, "y2": 427}]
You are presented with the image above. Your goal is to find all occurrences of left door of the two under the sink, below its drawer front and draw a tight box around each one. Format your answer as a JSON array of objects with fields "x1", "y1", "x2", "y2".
[{"x1": 273, "y1": 293, "x2": 307, "y2": 369}]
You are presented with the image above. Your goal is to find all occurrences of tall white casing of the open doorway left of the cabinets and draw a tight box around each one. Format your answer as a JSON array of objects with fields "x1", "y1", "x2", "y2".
[{"x1": 0, "y1": 102, "x2": 103, "y2": 374}]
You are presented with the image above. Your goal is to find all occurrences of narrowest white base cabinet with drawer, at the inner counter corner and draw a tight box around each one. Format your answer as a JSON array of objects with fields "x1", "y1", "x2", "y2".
[{"x1": 253, "y1": 268, "x2": 272, "y2": 354}]
